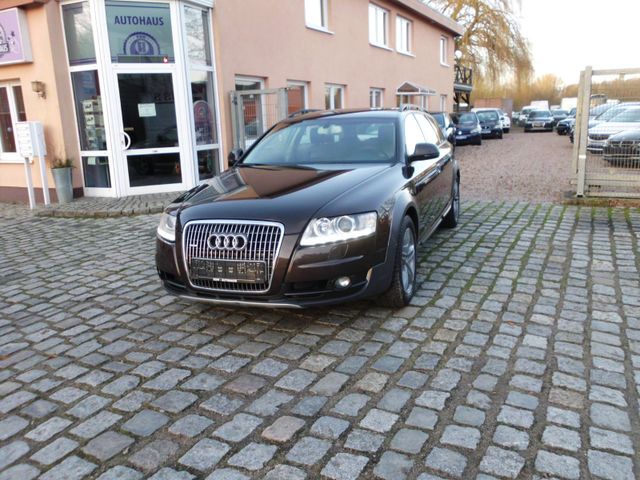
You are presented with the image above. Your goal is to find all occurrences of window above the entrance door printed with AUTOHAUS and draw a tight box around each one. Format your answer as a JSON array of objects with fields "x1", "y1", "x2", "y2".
[{"x1": 106, "y1": 1, "x2": 175, "y2": 63}]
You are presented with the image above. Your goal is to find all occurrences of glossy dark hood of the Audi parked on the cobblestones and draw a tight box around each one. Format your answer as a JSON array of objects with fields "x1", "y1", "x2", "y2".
[{"x1": 179, "y1": 164, "x2": 392, "y2": 233}]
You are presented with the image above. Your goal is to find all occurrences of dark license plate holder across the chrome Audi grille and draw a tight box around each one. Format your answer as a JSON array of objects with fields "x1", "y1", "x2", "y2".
[{"x1": 189, "y1": 258, "x2": 267, "y2": 283}]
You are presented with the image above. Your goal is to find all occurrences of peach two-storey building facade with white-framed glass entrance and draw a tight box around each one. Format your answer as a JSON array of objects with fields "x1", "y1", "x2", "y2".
[{"x1": 0, "y1": 0, "x2": 462, "y2": 201}]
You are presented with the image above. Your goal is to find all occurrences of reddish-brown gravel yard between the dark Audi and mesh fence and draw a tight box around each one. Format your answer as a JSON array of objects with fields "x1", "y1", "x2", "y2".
[{"x1": 456, "y1": 128, "x2": 574, "y2": 202}]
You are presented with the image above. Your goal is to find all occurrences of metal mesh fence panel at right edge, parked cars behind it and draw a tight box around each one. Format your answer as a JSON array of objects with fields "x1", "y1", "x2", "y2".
[{"x1": 573, "y1": 67, "x2": 640, "y2": 197}]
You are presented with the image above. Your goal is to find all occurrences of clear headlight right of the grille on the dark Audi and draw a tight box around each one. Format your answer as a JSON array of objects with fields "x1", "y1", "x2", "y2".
[{"x1": 300, "y1": 212, "x2": 378, "y2": 247}]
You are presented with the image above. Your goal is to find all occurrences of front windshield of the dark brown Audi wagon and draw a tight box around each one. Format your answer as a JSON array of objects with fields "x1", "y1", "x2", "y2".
[{"x1": 242, "y1": 116, "x2": 396, "y2": 165}]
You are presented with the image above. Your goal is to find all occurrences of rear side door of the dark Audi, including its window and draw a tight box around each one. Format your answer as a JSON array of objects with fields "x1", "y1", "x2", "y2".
[{"x1": 416, "y1": 114, "x2": 454, "y2": 220}]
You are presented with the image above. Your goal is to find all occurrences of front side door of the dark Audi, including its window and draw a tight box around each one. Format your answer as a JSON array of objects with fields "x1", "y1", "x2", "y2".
[{"x1": 404, "y1": 114, "x2": 439, "y2": 240}]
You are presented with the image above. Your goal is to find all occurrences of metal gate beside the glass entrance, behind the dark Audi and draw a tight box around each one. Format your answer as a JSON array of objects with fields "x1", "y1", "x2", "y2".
[{"x1": 231, "y1": 88, "x2": 290, "y2": 151}]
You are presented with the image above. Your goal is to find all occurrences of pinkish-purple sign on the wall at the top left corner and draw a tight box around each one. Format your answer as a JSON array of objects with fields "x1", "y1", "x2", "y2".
[{"x1": 0, "y1": 8, "x2": 32, "y2": 65}]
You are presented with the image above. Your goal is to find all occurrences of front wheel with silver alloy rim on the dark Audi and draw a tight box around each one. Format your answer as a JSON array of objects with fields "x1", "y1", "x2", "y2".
[{"x1": 379, "y1": 216, "x2": 418, "y2": 308}]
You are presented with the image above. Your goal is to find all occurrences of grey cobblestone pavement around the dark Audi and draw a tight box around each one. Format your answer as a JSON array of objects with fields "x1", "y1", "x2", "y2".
[{"x1": 0, "y1": 202, "x2": 640, "y2": 480}]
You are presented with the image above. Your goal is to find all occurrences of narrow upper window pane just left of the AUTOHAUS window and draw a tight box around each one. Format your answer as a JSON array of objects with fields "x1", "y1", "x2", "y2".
[{"x1": 62, "y1": 2, "x2": 96, "y2": 65}]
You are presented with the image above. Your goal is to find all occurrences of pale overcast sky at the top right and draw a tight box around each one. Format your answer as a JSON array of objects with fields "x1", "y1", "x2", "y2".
[{"x1": 521, "y1": 0, "x2": 640, "y2": 84}]
